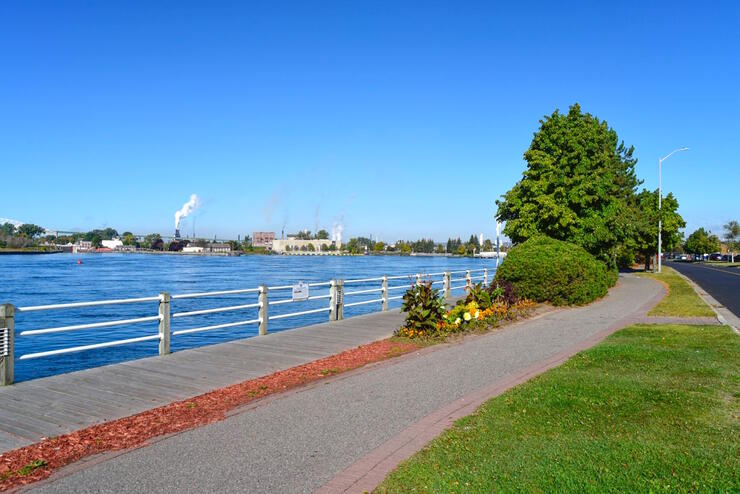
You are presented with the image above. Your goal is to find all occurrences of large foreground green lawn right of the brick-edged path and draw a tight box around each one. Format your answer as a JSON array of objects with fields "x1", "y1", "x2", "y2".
[{"x1": 376, "y1": 325, "x2": 740, "y2": 493}]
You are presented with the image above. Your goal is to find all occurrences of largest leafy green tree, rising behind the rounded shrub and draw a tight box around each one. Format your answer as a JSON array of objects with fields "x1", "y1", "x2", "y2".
[{"x1": 496, "y1": 103, "x2": 641, "y2": 260}]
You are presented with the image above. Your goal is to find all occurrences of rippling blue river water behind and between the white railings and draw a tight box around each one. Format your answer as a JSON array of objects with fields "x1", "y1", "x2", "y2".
[{"x1": 0, "y1": 254, "x2": 496, "y2": 381}]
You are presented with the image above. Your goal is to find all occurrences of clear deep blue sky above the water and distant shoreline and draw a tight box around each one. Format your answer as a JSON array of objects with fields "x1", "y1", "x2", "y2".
[{"x1": 0, "y1": 1, "x2": 740, "y2": 240}]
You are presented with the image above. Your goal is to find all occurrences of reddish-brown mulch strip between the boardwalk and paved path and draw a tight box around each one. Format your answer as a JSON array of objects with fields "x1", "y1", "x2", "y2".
[{"x1": 0, "y1": 340, "x2": 419, "y2": 491}]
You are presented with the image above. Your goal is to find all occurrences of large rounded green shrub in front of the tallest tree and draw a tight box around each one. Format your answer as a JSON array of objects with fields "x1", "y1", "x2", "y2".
[{"x1": 496, "y1": 235, "x2": 617, "y2": 305}]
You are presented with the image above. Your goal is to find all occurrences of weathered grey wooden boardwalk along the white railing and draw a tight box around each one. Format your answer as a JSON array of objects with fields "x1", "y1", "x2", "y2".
[{"x1": 0, "y1": 309, "x2": 404, "y2": 453}]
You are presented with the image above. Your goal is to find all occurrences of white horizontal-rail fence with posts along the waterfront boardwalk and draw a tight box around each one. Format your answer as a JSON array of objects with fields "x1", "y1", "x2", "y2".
[{"x1": 5, "y1": 269, "x2": 488, "y2": 385}]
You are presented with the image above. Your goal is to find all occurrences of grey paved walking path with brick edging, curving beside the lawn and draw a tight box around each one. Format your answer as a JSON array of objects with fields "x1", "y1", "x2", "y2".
[{"x1": 35, "y1": 275, "x2": 665, "y2": 493}]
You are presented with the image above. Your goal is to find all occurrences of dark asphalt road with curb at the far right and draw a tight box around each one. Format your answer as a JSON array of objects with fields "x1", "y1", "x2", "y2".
[{"x1": 669, "y1": 262, "x2": 740, "y2": 317}]
